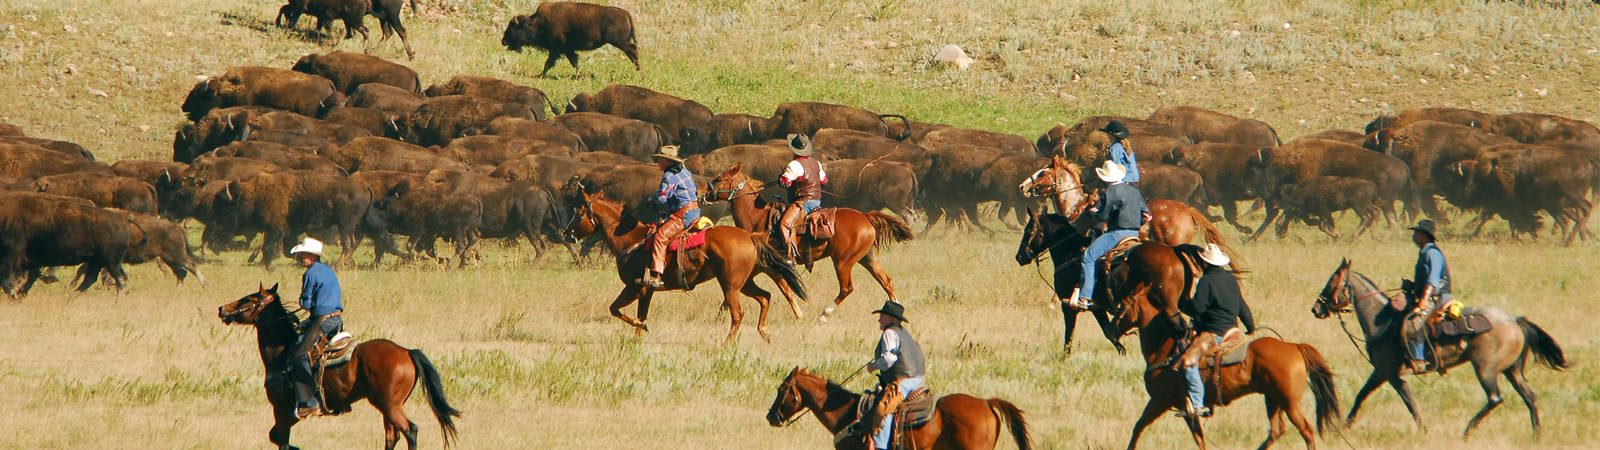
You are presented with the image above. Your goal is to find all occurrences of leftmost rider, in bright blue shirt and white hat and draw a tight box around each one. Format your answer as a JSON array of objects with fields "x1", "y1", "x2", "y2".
[{"x1": 290, "y1": 237, "x2": 344, "y2": 418}]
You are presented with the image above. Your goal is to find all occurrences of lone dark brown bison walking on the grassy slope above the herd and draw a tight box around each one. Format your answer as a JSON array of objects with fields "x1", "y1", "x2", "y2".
[{"x1": 501, "y1": 2, "x2": 640, "y2": 78}]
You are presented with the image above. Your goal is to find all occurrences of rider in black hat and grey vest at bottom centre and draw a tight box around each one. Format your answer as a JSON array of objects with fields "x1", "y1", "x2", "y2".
[{"x1": 850, "y1": 299, "x2": 928, "y2": 450}]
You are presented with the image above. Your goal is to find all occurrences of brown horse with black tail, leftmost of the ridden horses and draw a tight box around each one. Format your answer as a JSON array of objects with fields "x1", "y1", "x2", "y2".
[{"x1": 216, "y1": 285, "x2": 461, "y2": 450}]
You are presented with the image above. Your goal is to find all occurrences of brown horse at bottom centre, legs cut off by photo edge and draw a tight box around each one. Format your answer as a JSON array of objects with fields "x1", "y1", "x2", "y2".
[{"x1": 766, "y1": 367, "x2": 1034, "y2": 450}]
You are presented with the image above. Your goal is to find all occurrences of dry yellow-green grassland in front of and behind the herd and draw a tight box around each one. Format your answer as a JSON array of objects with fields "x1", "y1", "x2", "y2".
[{"x1": 0, "y1": 0, "x2": 1600, "y2": 448}]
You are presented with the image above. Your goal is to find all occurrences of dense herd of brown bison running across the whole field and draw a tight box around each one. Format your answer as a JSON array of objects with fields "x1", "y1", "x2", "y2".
[{"x1": 0, "y1": 45, "x2": 1600, "y2": 293}]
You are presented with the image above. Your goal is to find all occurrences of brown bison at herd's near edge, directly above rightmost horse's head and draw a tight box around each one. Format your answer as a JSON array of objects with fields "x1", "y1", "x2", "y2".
[{"x1": 1275, "y1": 176, "x2": 1379, "y2": 240}]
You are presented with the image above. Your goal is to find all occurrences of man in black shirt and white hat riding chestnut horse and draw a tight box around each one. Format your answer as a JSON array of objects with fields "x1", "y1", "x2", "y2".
[{"x1": 1178, "y1": 243, "x2": 1256, "y2": 416}]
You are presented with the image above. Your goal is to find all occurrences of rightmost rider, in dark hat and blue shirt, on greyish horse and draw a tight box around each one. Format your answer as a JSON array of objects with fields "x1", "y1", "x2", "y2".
[{"x1": 1405, "y1": 219, "x2": 1453, "y2": 373}]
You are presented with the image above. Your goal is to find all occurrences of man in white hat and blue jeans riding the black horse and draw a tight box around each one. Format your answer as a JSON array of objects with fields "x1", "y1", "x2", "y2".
[{"x1": 1066, "y1": 160, "x2": 1149, "y2": 309}]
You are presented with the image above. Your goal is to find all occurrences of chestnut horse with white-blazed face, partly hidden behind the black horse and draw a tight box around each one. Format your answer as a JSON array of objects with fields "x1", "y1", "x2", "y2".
[{"x1": 1018, "y1": 154, "x2": 1242, "y2": 265}]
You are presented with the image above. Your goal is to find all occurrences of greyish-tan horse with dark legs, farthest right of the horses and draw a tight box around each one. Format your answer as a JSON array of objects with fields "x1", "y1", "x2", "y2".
[{"x1": 1310, "y1": 259, "x2": 1566, "y2": 437}]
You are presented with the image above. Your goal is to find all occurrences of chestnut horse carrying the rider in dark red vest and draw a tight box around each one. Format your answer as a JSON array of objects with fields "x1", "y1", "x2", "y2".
[{"x1": 704, "y1": 163, "x2": 912, "y2": 322}]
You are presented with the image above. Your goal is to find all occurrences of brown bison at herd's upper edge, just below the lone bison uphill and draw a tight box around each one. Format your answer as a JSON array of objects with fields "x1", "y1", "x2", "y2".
[{"x1": 566, "y1": 85, "x2": 712, "y2": 144}]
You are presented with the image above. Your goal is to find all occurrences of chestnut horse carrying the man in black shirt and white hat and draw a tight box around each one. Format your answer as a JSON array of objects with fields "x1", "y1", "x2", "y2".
[{"x1": 1115, "y1": 243, "x2": 1339, "y2": 448}]
